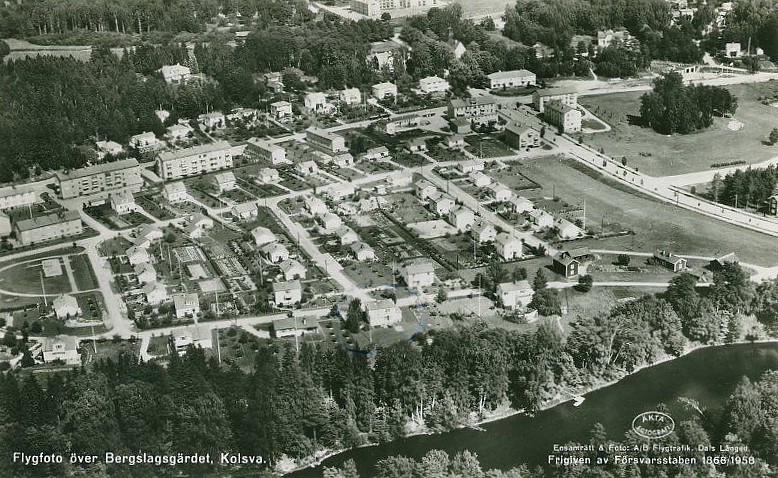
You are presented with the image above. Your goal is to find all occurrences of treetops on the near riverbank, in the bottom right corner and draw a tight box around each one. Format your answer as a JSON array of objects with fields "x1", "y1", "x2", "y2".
[{"x1": 323, "y1": 372, "x2": 778, "y2": 478}]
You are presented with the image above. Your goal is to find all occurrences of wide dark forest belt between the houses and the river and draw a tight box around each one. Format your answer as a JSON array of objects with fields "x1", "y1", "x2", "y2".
[{"x1": 0, "y1": 265, "x2": 778, "y2": 476}]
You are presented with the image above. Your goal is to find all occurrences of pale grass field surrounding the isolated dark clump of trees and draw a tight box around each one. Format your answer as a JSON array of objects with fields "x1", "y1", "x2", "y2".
[{"x1": 576, "y1": 82, "x2": 778, "y2": 176}]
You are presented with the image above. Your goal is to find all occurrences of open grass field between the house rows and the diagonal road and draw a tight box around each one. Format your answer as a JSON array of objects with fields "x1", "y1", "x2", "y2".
[{"x1": 522, "y1": 158, "x2": 778, "y2": 266}]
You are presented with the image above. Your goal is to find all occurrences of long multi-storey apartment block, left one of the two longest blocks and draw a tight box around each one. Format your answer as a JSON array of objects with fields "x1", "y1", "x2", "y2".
[{"x1": 54, "y1": 158, "x2": 143, "y2": 199}]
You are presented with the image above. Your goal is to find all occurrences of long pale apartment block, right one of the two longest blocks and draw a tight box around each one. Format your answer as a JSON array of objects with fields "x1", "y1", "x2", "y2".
[{"x1": 157, "y1": 141, "x2": 232, "y2": 181}]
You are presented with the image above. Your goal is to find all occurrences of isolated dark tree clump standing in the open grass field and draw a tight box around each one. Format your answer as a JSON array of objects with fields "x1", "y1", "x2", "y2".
[{"x1": 640, "y1": 72, "x2": 737, "y2": 134}]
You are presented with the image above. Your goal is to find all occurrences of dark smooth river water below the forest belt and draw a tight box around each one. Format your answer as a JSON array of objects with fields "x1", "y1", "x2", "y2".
[{"x1": 289, "y1": 343, "x2": 778, "y2": 478}]
